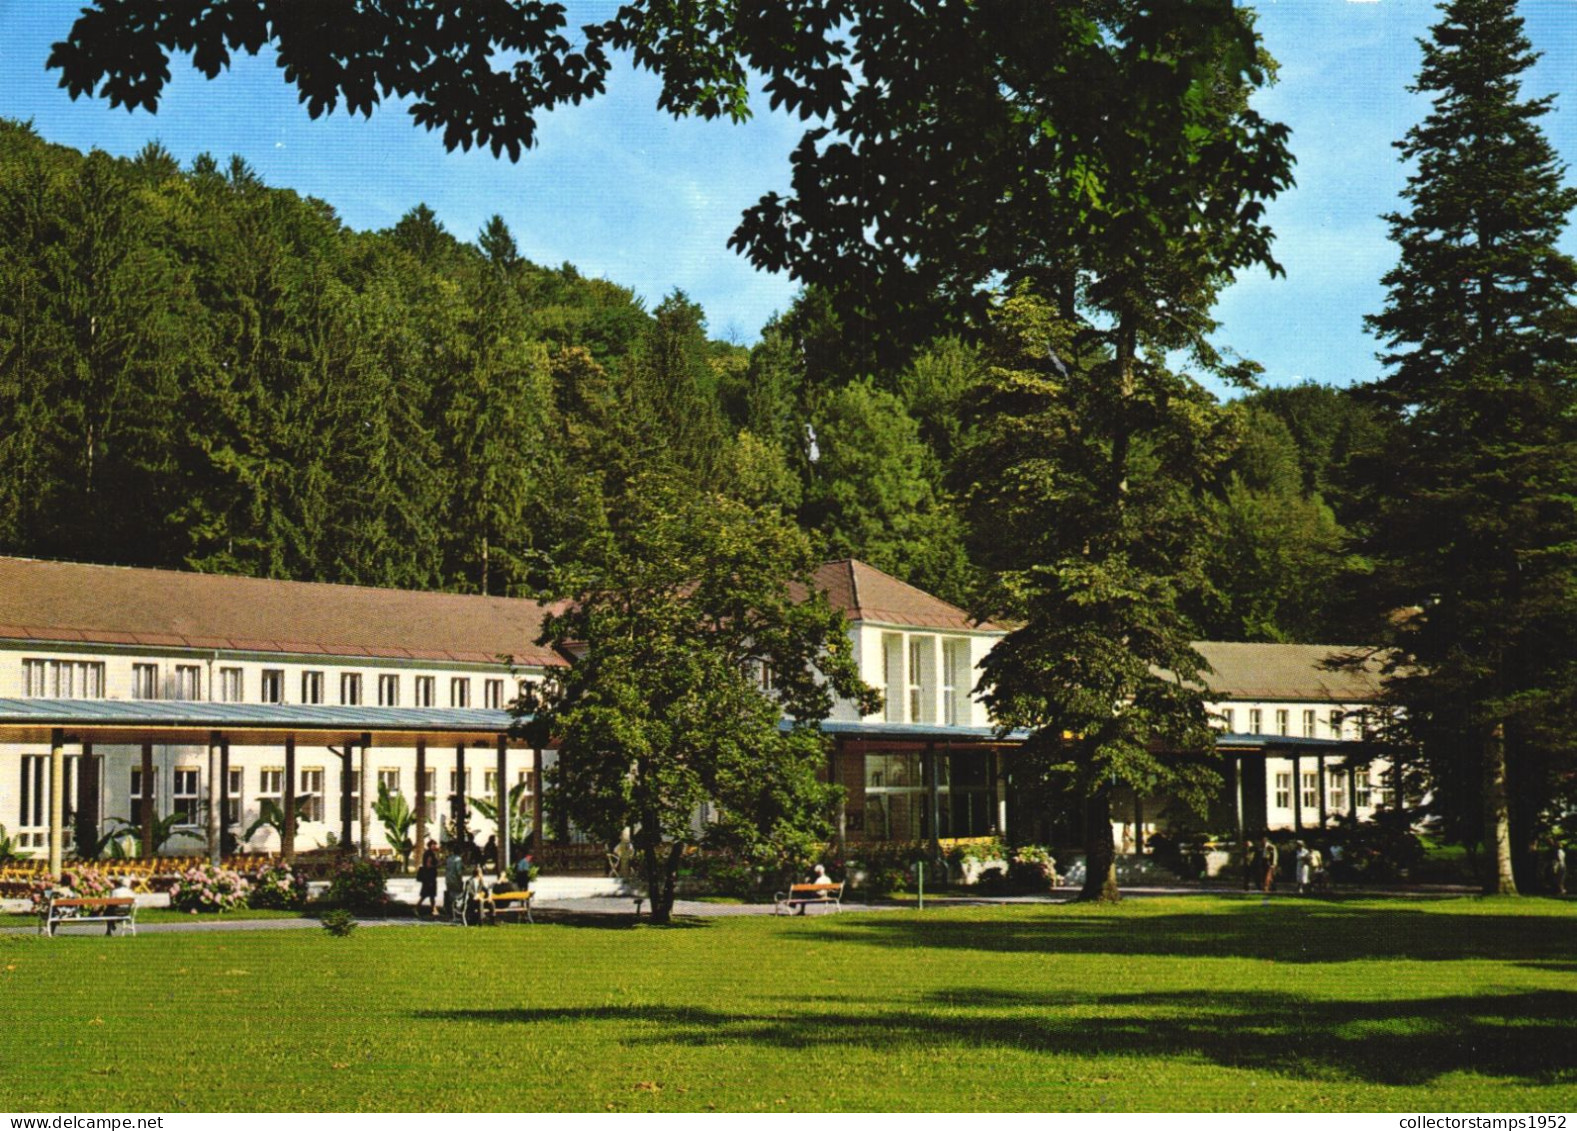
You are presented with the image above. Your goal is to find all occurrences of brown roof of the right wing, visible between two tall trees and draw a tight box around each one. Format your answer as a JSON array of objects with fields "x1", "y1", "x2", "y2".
[{"x1": 1194, "y1": 640, "x2": 1383, "y2": 704}]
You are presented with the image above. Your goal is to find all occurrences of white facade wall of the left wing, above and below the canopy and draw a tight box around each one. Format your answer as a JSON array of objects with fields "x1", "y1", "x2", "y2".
[{"x1": 0, "y1": 642, "x2": 541, "y2": 855}]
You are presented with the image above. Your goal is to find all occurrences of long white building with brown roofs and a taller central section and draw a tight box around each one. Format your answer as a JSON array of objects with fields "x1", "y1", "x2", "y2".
[{"x1": 0, "y1": 558, "x2": 1386, "y2": 870}]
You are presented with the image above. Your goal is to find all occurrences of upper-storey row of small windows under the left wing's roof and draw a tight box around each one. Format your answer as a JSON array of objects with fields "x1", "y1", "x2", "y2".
[{"x1": 22, "y1": 659, "x2": 505, "y2": 710}]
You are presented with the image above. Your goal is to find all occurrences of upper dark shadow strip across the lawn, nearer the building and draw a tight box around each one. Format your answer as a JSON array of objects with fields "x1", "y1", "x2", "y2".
[{"x1": 831, "y1": 899, "x2": 1577, "y2": 962}]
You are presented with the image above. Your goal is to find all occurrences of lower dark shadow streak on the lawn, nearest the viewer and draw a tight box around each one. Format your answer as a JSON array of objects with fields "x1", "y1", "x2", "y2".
[{"x1": 416, "y1": 989, "x2": 1577, "y2": 1085}]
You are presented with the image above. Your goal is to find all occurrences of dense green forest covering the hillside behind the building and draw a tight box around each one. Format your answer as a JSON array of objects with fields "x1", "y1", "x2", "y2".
[{"x1": 0, "y1": 121, "x2": 1381, "y2": 640}]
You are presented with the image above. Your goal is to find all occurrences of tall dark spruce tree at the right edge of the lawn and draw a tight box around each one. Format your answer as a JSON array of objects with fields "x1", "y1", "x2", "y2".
[{"x1": 1369, "y1": 0, "x2": 1577, "y2": 894}]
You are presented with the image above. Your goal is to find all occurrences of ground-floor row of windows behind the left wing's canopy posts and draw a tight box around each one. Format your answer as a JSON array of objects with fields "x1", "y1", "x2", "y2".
[{"x1": 17, "y1": 754, "x2": 533, "y2": 830}]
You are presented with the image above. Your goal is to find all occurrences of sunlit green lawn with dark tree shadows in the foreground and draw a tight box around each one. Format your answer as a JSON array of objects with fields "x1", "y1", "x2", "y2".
[{"x1": 0, "y1": 896, "x2": 1577, "y2": 1112}]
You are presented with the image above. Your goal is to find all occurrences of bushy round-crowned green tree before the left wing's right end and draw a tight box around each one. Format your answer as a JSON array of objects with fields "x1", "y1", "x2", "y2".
[{"x1": 524, "y1": 478, "x2": 877, "y2": 923}]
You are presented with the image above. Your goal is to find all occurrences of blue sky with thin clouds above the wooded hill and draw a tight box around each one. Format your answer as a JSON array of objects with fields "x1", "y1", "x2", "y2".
[{"x1": 0, "y1": 0, "x2": 1577, "y2": 385}]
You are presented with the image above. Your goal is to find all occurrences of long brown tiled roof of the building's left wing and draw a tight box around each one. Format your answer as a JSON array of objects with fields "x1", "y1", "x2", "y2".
[{"x1": 0, "y1": 557, "x2": 563, "y2": 666}]
